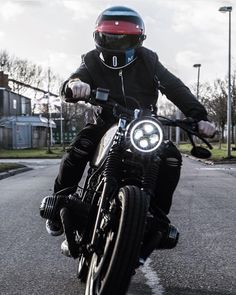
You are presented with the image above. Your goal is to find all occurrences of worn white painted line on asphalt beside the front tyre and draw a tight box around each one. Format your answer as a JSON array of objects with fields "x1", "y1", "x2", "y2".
[{"x1": 140, "y1": 258, "x2": 164, "y2": 295}]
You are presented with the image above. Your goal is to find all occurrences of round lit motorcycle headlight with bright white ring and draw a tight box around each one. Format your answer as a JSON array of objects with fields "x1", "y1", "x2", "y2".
[{"x1": 130, "y1": 119, "x2": 163, "y2": 153}]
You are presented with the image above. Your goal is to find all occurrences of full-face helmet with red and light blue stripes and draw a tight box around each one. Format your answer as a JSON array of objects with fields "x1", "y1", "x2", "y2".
[{"x1": 94, "y1": 6, "x2": 146, "y2": 69}]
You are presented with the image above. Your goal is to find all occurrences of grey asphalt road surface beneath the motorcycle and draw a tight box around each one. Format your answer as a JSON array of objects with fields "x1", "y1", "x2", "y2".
[{"x1": 0, "y1": 159, "x2": 236, "y2": 295}]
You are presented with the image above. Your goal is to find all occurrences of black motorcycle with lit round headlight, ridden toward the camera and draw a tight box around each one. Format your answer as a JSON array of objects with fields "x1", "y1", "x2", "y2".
[{"x1": 40, "y1": 88, "x2": 212, "y2": 295}]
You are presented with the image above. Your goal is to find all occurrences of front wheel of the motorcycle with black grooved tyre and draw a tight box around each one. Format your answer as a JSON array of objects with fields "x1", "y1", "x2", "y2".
[{"x1": 85, "y1": 186, "x2": 149, "y2": 295}]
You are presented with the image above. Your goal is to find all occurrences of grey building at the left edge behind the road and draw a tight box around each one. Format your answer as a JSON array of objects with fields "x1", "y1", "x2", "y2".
[{"x1": 0, "y1": 72, "x2": 56, "y2": 149}]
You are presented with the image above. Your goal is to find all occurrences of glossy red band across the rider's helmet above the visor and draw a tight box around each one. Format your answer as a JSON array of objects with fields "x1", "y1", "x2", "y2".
[{"x1": 96, "y1": 20, "x2": 142, "y2": 35}]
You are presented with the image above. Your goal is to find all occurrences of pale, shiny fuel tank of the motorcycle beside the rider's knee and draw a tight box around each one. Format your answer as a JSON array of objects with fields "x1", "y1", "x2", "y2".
[{"x1": 90, "y1": 124, "x2": 118, "y2": 167}]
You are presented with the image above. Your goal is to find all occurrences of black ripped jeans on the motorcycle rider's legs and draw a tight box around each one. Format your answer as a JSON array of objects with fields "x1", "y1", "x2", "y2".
[{"x1": 54, "y1": 124, "x2": 182, "y2": 214}]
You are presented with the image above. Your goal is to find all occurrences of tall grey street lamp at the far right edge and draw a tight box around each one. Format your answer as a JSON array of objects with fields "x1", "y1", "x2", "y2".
[{"x1": 219, "y1": 6, "x2": 232, "y2": 158}]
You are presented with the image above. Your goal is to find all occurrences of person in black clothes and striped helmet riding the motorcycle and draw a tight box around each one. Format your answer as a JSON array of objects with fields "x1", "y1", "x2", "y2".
[{"x1": 42, "y1": 6, "x2": 215, "y2": 254}]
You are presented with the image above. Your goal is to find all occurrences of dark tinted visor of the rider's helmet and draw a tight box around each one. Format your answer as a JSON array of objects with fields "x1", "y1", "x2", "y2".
[{"x1": 95, "y1": 32, "x2": 141, "y2": 50}]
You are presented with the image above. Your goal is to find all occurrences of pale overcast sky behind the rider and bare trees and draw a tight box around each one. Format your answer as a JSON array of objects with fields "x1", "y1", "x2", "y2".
[{"x1": 0, "y1": 0, "x2": 236, "y2": 85}]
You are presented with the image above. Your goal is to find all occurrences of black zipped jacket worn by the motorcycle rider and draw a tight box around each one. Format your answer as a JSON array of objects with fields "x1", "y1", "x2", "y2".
[{"x1": 61, "y1": 47, "x2": 207, "y2": 121}]
